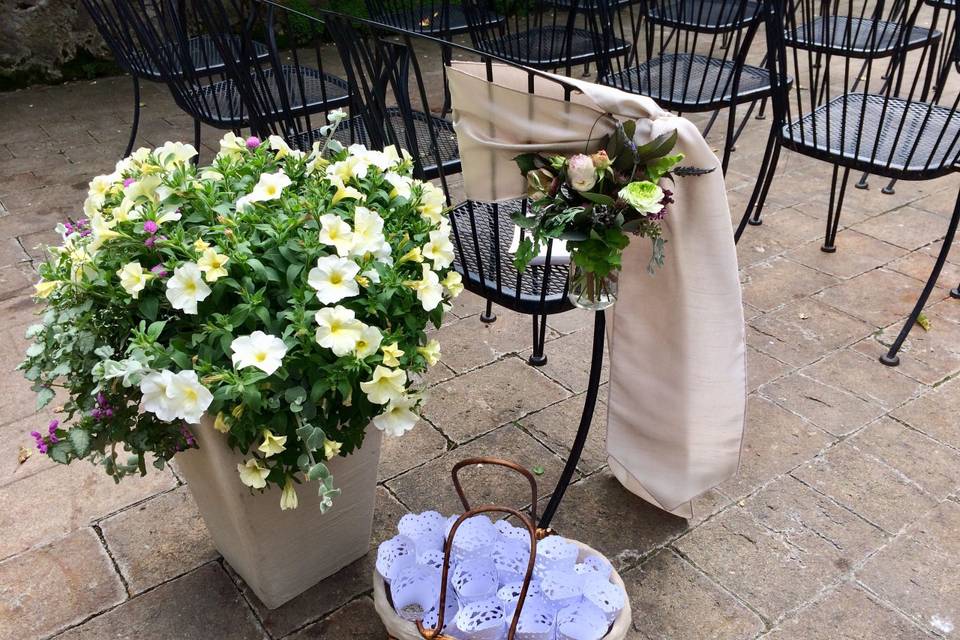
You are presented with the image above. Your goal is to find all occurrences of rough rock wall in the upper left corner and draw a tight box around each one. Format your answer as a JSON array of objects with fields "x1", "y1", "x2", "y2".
[{"x1": 0, "y1": 0, "x2": 110, "y2": 87}]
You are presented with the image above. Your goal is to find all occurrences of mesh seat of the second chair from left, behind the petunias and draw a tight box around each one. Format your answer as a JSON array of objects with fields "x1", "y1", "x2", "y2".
[{"x1": 194, "y1": 65, "x2": 350, "y2": 128}]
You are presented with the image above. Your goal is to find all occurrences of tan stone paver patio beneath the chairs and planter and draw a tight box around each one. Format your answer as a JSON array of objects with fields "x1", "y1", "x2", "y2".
[{"x1": 0, "y1": 61, "x2": 960, "y2": 640}]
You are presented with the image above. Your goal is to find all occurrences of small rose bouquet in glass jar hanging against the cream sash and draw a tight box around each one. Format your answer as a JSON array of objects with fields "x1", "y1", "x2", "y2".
[{"x1": 513, "y1": 121, "x2": 712, "y2": 310}]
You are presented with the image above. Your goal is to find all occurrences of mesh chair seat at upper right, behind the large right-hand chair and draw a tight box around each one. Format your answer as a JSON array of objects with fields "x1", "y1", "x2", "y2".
[{"x1": 786, "y1": 16, "x2": 940, "y2": 58}]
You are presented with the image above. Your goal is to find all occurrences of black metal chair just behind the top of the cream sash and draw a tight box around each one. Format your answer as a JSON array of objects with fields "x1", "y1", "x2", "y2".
[{"x1": 597, "y1": 0, "x2": 772, "y2": 172}]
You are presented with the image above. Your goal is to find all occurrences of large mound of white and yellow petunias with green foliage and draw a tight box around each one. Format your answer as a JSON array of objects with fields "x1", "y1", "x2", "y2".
[{"x1": 20, "y1": 112, "x2": 463, "y2": 509}]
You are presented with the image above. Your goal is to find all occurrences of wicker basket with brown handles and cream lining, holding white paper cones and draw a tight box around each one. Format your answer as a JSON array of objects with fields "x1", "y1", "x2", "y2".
[{"x1": 373, "y1": 458, "x2": 633, "y2": 640}]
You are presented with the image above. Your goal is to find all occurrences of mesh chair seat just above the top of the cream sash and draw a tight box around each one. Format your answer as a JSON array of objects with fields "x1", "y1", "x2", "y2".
[{"x1": 599, "y1": 53, "x2": 771, "y2": 111}]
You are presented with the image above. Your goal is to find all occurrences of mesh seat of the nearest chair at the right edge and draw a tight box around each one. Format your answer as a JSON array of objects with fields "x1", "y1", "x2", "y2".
[{"x1": 783, "y1": 93, "x2": 960, "y2": 179}]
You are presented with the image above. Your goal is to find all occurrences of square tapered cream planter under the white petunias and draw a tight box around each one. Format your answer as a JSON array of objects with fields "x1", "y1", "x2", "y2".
[{"x1": 176, "y1": 417, "x2": 382, "y2": 609}]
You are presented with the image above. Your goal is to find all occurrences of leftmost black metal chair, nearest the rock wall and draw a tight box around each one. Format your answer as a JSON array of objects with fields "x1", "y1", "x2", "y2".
[{"x1": 83, "y1": 0, "x2": 267, "y2": 156}]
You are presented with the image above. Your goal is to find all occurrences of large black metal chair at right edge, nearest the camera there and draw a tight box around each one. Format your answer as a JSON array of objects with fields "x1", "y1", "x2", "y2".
[{"x1": 736, "y1": 0, "x2": 960, "y2": 366}]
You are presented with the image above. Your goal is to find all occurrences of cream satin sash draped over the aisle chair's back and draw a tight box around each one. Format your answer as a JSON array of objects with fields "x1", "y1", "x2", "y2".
[{"x1": 449, "y1": 62, "x2": 746, "y2": 517}]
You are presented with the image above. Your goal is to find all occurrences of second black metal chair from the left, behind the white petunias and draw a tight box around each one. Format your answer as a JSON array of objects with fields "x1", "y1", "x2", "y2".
[{"x1": 118, "y1": 0, "x2": 349, "y2": 158}]
